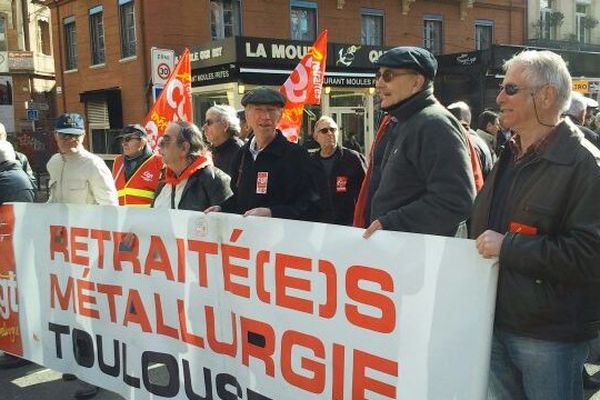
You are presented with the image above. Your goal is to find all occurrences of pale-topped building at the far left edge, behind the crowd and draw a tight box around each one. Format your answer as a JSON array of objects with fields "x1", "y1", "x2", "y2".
[{"x1": 0, "y1": 0, "x2": 56, "y2": 170}]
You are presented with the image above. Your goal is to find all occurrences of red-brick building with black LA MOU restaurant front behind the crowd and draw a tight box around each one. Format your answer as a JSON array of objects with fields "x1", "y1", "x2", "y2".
[{"x1": 45, "y1": 0, "x2": 526, "y2": 159}]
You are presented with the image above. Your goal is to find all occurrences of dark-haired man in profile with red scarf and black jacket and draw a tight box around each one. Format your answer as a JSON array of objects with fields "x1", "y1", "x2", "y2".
[{"x1": 152, "y1": 121, "x2": 232, "y2": 211}]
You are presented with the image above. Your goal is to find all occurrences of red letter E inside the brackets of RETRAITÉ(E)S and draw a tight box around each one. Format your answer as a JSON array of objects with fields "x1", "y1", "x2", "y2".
[{"x1": 275, "y1": 253, "x2": 313, "y2": 314}]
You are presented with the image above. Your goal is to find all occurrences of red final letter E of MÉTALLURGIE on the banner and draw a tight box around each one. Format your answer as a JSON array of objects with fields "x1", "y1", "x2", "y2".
[{"x1": 352, "y1": 350, "x2": 398, "y2": 400}]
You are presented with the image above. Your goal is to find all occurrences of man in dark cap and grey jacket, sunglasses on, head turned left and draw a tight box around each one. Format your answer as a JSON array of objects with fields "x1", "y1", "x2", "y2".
[{"x1": 354, "y1": 47, "x2": 475, "y2": 238}]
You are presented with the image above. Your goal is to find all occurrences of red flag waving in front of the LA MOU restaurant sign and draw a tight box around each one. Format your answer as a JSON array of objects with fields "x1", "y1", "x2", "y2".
[{"x1": 278, "y1": 30, "x2": 327, "y2": 143}]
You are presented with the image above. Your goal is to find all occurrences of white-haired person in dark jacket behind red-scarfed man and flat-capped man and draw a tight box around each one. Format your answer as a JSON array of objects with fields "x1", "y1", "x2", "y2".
[{"x1": 202, "y1": 105, "x2": 244, "y2": 175}]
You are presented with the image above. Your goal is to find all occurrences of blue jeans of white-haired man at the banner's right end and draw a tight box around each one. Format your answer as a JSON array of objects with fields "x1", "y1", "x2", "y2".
[{"x1": 488, "y1": 329, "x2": 589, "y2": 400}]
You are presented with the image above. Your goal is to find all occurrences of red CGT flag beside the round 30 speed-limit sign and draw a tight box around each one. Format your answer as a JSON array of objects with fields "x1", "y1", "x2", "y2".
[{"x1": 143, "y1": 49, "x2": 192, "y2": 150}]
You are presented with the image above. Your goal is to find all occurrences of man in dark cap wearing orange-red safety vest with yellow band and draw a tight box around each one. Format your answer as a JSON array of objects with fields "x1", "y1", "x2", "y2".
[{"x1": 113, "y1": 124, "x2": 163, "y2": 207}]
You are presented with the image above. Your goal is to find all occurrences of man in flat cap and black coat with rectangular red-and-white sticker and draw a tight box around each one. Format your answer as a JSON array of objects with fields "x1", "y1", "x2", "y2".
[{"x1": 206, "y1": 87, "x2": 321, "y2": 220}]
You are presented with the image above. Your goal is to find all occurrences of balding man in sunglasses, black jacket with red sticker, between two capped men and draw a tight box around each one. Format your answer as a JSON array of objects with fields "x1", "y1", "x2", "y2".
[{"x1": 311, "y1": 116, "x2": 366, "y2": 226}]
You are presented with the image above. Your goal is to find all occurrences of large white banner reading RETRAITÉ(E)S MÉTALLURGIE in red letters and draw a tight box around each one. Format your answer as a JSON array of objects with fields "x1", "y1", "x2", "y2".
[{"x1": 0, "y1": 204, "x2": 497, "y2": 400}]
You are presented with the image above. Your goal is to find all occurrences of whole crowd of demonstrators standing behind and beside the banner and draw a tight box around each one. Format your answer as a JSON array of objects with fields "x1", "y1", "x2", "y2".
[{"x1": 0, "y1": 46, "x2": 600, "y2": 400}]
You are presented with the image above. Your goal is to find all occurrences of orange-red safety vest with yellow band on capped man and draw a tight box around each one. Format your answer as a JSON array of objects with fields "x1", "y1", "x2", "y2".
[{"x1": 113, "y1": 154, "x2": 163, "y2": 207}]
